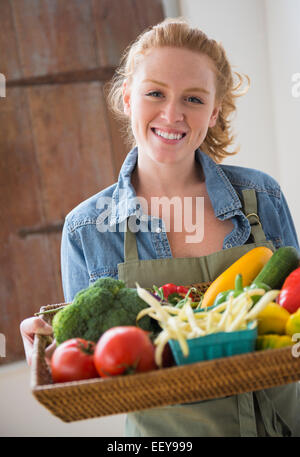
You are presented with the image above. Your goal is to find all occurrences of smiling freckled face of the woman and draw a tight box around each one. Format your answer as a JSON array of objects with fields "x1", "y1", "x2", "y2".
[{"x1": 123, "y1": 47, "x2": 219, "y2": 164}]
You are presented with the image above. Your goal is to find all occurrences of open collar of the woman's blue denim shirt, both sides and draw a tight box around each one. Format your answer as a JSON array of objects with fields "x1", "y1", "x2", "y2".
[{"x1": 110, "y1": 147, "x2": 242, "y2": 225}]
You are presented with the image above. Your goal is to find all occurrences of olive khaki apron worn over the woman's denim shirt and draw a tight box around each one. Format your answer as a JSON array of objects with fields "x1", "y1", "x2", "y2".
[{"x1": 118, "y1": 189, "x2": 299, "y2": 437}]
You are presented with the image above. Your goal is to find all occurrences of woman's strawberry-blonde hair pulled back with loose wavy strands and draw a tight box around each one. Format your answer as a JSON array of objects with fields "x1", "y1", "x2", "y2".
[{"x1": 105, "y1": 18, "x2": 250, "y2": 162}]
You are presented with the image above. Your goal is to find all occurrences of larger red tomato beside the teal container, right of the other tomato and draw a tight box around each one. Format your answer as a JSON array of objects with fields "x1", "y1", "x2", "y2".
[{"x1": 94, "y1": 326, "x2": 157, "y2": 377}]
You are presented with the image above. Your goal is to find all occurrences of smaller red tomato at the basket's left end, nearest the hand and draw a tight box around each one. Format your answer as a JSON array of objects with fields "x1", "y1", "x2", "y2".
[{"x1": 51, "y1": 338, "x2": 99, "y2": 382}]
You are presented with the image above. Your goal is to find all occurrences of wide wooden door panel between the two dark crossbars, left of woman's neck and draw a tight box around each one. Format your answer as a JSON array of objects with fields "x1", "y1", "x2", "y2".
[{"x1": 28, "y1": 82, "x2": 115, "y2": 221}]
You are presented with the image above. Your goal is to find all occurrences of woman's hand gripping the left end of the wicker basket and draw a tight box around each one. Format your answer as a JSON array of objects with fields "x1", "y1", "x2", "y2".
[{"x1": 20, "y1": 317, "x2": 56, "y2": 365}]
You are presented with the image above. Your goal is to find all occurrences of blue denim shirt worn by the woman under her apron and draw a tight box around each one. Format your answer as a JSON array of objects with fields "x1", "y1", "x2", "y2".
[{"x1": 61, "y1": 148, "x2": 299, "y2": 302}]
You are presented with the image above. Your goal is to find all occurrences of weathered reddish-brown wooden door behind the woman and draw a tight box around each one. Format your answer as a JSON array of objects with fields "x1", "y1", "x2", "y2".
[{"x1": 0, "y1": 0, "x2": 164, "y2": 364}]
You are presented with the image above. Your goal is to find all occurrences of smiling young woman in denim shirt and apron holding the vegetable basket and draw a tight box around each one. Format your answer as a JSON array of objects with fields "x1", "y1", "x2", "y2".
[{"x1": 21, "y1": 19, "x2": 299, "y2": 436}]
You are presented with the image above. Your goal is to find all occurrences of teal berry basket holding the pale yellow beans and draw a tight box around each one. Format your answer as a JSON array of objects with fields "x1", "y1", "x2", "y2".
[{"x1": 169, "y1": 324, "x2": 257, "y2": 365}]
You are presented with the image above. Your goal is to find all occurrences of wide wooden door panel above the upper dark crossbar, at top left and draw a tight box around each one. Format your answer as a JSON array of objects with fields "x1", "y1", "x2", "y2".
[{"x1": 11, "y1": 0, "x2": 100, "y2": 77}]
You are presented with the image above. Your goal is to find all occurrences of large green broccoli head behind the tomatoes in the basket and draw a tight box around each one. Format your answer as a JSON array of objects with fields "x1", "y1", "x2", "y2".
[{"x1": 52, "y1": 278, "x2": 158, "y2": 344}]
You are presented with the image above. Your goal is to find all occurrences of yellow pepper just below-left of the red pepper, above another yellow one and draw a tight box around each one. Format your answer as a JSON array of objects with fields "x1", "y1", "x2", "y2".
[{"x1": 257, "y1": 302, "x2": 290, "y2": 335}]
